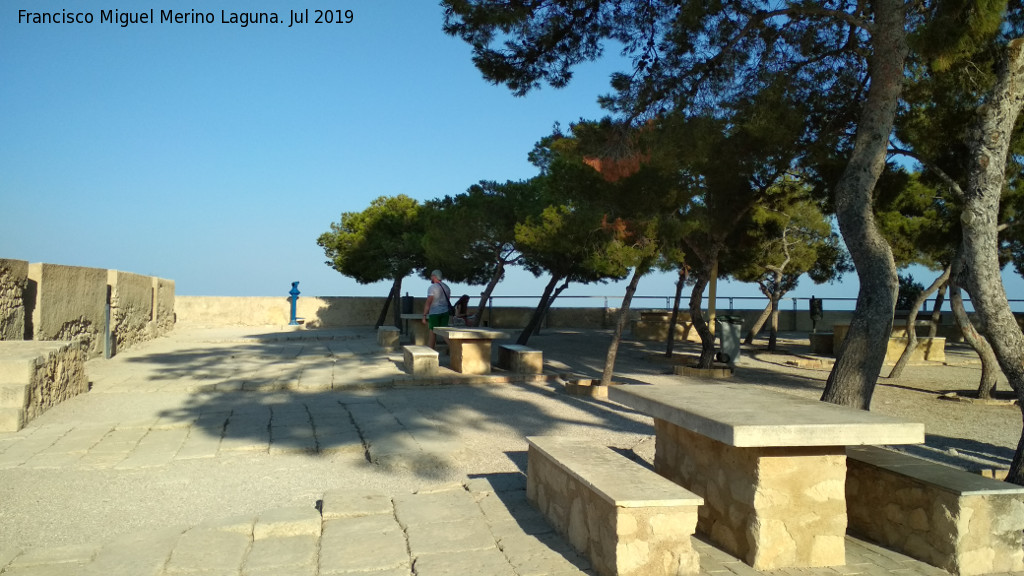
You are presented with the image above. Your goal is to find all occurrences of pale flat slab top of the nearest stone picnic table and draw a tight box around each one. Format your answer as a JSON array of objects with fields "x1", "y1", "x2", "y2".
[{"x1": 608, "y1": 382, "x2": 925, "y2": 448}]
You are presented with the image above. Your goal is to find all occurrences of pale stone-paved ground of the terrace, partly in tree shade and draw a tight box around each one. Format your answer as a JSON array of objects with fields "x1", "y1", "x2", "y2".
[{"x1": 0, "y1": 326, "x2": 1019, "y2": 576}]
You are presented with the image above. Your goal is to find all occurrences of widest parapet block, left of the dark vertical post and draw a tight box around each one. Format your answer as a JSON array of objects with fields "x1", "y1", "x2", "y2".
[{"x1": 29, "y1": 262, "x2": 106, "y2": 358}]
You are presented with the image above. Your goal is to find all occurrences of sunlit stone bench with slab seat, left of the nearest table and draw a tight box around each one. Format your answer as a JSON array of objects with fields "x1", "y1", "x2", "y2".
[{"x1": 526, "y1": 437, "x2": 703, "y2": 576}]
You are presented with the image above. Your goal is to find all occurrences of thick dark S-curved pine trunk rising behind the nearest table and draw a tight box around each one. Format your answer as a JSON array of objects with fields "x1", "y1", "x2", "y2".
[{"x1": 821, "y1": 0, "x2": 907, "y2": 410}]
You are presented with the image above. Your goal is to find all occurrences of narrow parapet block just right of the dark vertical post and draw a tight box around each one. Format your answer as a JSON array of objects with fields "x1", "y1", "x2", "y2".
[{"x1": 106, "y1": 270, "x2": 157, "y2": 356}]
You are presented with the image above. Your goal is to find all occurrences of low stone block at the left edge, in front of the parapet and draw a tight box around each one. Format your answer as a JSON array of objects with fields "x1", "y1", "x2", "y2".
[{"x1": 0, "y1": 339, "x2": 89, "y2": 431}]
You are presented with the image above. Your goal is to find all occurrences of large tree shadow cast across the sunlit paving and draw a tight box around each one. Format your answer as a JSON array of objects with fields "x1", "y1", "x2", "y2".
[{"x1": 112, "y1": 334, "x2": 652, "y2": 481}]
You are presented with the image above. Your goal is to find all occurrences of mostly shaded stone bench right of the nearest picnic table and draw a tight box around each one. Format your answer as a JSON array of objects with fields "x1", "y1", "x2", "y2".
[{"x1": 846, "y1": 446, "x2": 1024, "y2": 575}]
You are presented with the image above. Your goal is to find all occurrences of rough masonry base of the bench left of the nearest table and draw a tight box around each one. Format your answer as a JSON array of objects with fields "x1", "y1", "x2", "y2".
[{"x1": 526, "y1": 449, "x2": 699, "y2": 576}]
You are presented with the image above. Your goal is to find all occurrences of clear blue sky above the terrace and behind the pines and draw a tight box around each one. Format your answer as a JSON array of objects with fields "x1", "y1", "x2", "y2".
[{"x1": 0, "y1": 0, "x2": 1016, "y2": 309}]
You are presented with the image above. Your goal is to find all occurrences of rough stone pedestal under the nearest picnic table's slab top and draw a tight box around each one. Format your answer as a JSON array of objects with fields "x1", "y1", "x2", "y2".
[{"x1": 654, "y1": 418, "x2": 847, "y2": 570}]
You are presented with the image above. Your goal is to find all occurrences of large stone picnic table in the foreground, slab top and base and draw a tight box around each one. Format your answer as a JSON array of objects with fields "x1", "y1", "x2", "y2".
[{"x1": 608, "y1": 382, "x2": 925, "y2": 570}]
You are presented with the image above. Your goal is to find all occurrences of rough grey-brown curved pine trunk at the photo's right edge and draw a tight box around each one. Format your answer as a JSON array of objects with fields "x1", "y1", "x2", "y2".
[{"x1": 959, "y1": 38, "x2": 1024, "y2": 486}]
